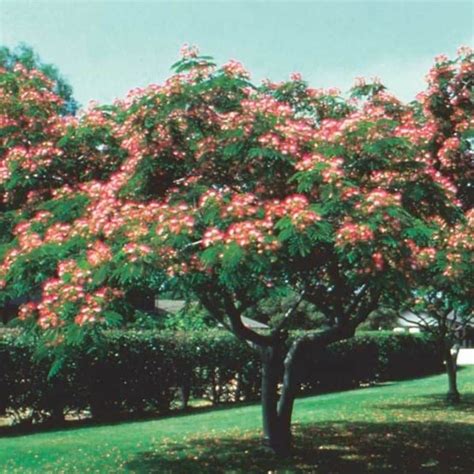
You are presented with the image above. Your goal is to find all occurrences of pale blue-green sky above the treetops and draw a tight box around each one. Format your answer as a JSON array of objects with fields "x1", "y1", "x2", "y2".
[{"x1": 0, "y1": 0, "x2": 474, "y2": 105}]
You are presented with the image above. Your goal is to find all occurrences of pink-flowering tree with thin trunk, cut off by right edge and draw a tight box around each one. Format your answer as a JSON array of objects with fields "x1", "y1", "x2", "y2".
[{"x1": 396, "y1": 47, "x2": 474, "y2": 403}]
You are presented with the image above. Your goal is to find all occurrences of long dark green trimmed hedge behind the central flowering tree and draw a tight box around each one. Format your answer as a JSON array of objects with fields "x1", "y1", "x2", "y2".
[{"x1": 0, "y1": 330, "x2": 442, "y2": 421}]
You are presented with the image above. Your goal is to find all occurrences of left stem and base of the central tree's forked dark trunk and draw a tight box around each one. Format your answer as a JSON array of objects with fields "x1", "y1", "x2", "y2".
[{"x1": 261, "y1": 346, "x2": 293, "y2": 456}]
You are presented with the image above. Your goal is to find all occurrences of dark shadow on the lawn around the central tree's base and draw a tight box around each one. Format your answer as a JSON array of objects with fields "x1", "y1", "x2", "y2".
[{"x1": 125, "y1": 422, "x2": 474, "y2": 474}]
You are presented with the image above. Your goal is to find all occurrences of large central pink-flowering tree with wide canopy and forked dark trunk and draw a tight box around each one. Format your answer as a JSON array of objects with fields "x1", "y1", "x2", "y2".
[{"x1": 0, "y1": 48, "x2": 456, "y2": 454}]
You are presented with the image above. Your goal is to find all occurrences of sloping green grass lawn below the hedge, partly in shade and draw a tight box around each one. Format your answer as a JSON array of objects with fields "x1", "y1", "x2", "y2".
[{"x1": 0, "y1": 367, "x2": 474, "y2": 474}]
